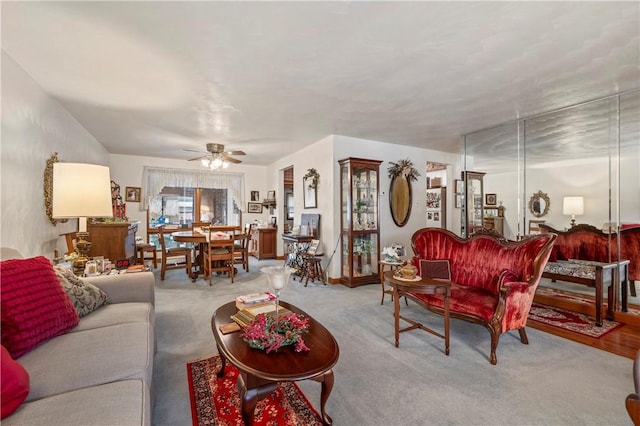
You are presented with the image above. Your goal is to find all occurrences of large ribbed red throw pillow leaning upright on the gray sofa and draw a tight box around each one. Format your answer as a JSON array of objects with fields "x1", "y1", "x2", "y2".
[{"x1": 0, "y1": 256, "x2": 79, "y2": 359}]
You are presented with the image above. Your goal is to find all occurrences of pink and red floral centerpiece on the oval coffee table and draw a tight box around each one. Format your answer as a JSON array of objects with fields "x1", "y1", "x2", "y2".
[{"x1": 240, "y1": 313, "x2": 309, "y2": 353}]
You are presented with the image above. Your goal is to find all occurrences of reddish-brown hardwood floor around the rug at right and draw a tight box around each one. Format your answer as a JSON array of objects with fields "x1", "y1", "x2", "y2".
[{"x1": 527, "y1": 295, "x2": 640, "y2": 359}]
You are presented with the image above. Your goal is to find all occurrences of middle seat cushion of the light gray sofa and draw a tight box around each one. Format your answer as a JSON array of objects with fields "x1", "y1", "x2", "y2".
[{"x1": 20, "y1": 322, "x2": 155, "y2": 402}]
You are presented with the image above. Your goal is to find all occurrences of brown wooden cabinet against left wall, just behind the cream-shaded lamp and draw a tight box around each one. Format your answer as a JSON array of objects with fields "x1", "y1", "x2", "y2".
[{"x1": 87, "y1": 222, "x2": 138, "y2": 264}]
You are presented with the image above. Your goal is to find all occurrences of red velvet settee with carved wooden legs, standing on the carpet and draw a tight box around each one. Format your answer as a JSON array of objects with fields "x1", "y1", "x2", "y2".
[{"x1": 411, "y1": 228, "x2": 556, "y2": 365}]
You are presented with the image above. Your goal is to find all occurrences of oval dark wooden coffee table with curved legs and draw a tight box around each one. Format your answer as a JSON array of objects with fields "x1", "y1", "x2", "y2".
[{"x1": 211, "y1": 301, "x2": 340, "y2": 425}]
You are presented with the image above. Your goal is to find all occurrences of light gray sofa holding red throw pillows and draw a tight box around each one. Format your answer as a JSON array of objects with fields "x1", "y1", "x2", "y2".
[{"x1": 1, "y1": 248, "x2": 155, "y2": 426}]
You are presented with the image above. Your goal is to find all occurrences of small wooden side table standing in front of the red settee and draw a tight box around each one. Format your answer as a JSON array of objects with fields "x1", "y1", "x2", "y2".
[{"x1": 384, "y1": 271, "x2": 451, "y2": 355}]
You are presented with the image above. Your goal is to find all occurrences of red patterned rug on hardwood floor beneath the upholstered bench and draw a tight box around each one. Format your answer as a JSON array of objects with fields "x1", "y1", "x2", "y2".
[{"x1": 528, "y1": 303, "x2": 622, "y2": 338}]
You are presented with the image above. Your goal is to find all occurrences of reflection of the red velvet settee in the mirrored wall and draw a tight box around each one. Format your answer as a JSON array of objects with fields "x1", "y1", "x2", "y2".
[{"x1": 540, "y1": 224, "x2": 640, "y2": 296}]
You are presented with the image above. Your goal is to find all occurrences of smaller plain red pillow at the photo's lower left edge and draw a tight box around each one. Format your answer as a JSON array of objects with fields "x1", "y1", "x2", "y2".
[{"x1": 0, "y1": 346, "x2": 29, "y2": 419}]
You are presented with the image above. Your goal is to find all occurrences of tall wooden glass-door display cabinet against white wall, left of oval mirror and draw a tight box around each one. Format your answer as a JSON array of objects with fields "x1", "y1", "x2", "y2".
[{"x1": 338, "y1": 158, "x2": 382, "y2": 287}]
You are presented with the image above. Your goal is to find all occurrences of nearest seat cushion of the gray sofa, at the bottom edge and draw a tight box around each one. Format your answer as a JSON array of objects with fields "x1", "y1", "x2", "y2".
[{"x1": 2, "y1": 379, "x2": 152, "y2": 426}]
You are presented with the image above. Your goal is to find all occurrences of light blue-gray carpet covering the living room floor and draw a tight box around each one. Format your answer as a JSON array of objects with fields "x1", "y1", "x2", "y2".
[{"x1": 153, "y1": 259, "x2": 633, "y2": 426}]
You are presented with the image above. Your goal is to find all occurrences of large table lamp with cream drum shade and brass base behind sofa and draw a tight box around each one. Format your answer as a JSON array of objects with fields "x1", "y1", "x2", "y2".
[{"x1": 51, "y1": 163, "x2": 113, "y2": 275}]
